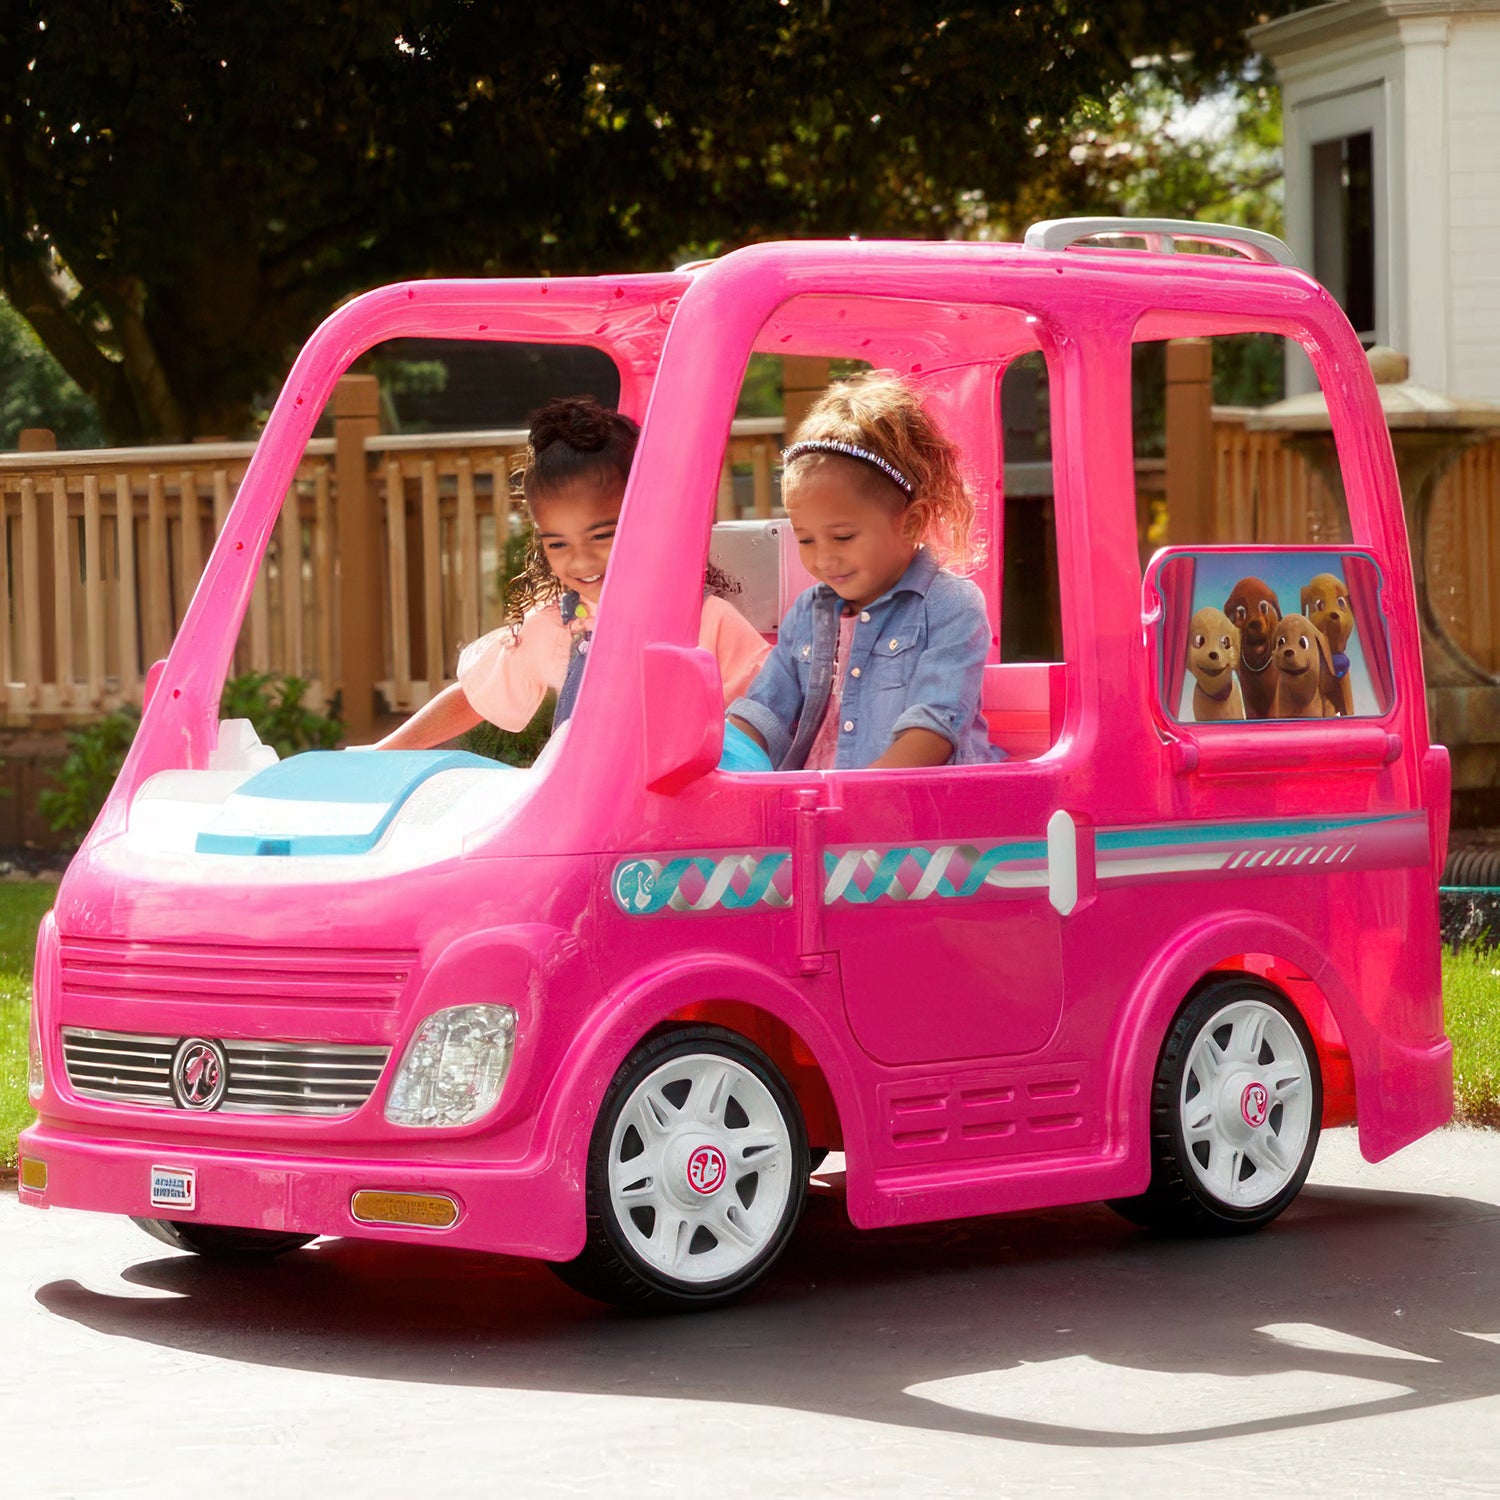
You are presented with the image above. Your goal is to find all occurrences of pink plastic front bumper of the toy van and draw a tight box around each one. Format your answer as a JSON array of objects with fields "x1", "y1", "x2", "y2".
[{"x1": 18, "y1": 1121, "x2": 585, "y2": 1260}]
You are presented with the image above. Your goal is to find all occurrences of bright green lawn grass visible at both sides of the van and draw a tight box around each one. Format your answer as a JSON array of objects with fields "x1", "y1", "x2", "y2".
[{"x1": 0, "y1": 881, "x2": 1500, "y2": 1170}]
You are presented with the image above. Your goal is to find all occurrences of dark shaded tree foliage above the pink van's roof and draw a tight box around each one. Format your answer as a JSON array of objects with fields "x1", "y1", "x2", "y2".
[{"x1": 0, "y1": 0, "x2": 1295, "y2": 441}]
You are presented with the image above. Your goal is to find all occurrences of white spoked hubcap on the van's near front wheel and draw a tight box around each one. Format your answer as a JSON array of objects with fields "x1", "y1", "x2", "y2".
[{"x1": 609, "y1": 1053, "x2": 792, "y2": 1284}]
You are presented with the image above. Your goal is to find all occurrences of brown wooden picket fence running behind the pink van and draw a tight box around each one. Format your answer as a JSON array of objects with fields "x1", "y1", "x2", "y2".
[{"x1": 0, "y1": 364, "x2": 1500, "y2": 737}]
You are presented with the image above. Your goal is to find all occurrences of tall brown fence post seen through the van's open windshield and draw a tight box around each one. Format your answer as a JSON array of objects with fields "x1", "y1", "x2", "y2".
[{"x1": 333, "y1": 375, "x2": 383, "y2": 741}]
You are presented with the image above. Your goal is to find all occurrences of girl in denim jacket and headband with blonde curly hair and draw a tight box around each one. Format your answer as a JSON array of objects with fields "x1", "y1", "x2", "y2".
[{"x1": 729, "y1": 372, "x2": 1002, "y2": 770}]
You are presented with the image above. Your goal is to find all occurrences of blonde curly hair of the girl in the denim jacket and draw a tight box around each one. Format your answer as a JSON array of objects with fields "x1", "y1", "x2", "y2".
[{"x1": 783, "y1": 371, "x2": 984, "y2": 572}]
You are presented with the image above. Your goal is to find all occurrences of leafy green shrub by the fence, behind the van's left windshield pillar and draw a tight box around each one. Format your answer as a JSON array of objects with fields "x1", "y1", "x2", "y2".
[{"x1": 36, "y1": 672, "x2": 342, "y2": 839}]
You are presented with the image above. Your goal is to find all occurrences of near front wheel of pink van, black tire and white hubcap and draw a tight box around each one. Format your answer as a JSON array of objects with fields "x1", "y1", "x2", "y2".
[{"x1": 552, "y1": 1026, "x2": 812, "y2": 1313}]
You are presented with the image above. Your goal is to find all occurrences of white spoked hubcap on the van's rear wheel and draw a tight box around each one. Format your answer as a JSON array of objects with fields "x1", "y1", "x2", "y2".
[{"x1": 1178, "y1": 1001, "x2": 1313, "y2": 1209}]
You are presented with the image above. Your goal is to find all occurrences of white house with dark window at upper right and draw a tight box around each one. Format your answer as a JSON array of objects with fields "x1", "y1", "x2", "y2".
[{"x1": 1250, "y1": 0, "x2": 1500, "y2": 401}]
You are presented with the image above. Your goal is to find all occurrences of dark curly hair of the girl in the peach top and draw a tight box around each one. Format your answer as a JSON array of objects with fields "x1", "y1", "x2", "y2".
[{"x1": 506, "y1": 396, "x2": 740, "y2": 626}]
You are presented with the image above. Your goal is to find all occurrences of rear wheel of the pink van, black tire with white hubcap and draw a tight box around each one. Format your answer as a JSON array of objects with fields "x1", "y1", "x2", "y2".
[{"x1": 1110, "y1": 980, "x2": 1323, "y2": 1235}]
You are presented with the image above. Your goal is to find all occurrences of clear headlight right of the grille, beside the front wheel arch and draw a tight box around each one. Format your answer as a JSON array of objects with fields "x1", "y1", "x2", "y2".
[{"x1": 386, "y1": 1005, "x2": 516, "y2": 1125}]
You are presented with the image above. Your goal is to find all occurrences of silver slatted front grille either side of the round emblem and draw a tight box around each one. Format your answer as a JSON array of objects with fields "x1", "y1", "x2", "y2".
[{"x1": 63, "y1": 1026, "x2": 390, "y2": 1115}]
